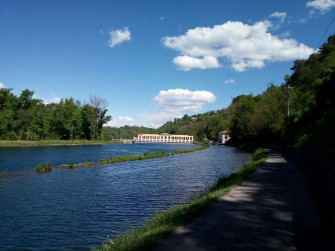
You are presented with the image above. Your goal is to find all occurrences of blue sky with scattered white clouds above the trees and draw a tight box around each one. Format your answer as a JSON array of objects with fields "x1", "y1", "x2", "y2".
[{"x1": 0, "y1": 0, "x2": 335, "y2": 127}]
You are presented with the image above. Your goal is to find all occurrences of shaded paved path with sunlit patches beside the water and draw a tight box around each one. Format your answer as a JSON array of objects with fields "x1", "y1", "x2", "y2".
[{"x1": 159, "y1": 150, "x2": 333, "y2": 251}]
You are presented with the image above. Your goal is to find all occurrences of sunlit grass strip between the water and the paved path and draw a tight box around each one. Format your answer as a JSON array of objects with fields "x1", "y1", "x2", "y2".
[{"x1": 92, "y1": 148, "x2": 268, "y2": 251}]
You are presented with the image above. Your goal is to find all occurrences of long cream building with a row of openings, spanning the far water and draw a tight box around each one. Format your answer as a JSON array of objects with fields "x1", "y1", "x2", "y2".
[{"x1": 134, "y1": 133, "x2": 193, "y2": 143}]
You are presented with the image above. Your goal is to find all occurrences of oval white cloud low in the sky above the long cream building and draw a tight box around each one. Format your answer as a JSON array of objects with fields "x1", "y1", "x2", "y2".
[{"x1": 154, "y1": 89, "x2": 216, "y2": 112}]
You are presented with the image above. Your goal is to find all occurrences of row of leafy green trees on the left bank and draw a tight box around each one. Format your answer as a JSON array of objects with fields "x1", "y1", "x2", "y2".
[{"x1": 0, "y1": 88, "x2": 111, "y2": 140}]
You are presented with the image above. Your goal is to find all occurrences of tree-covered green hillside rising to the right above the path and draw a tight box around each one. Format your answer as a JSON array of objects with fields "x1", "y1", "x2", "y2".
[{"x1": 129, "y1": 35, "x2": 335, "y2": 157}]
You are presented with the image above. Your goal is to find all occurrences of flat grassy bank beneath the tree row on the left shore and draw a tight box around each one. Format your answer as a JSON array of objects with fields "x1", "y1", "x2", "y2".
[{"x1": 0, "y1": 140, "x2": 124, "y2": 147}]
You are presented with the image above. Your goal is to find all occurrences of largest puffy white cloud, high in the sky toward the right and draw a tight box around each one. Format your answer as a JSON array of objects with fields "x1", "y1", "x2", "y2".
[{"x1": 162, "y1": 20, "x2": 314, "y2": 72}]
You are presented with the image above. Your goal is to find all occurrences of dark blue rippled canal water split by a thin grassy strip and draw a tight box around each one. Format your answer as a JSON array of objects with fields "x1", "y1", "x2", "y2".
[{"x1": 0, "y1": 143, "x2": 251, "y2": 250}]
